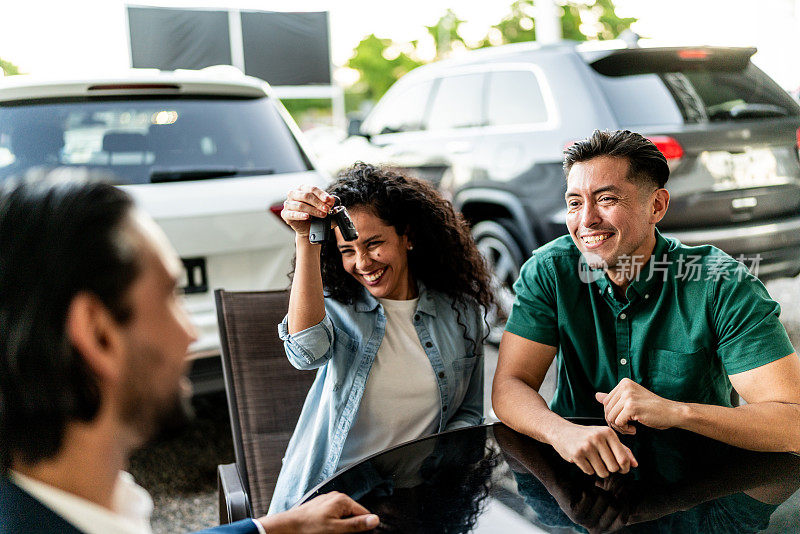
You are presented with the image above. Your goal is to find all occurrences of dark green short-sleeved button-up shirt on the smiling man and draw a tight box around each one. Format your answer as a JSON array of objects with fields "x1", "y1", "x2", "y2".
[{"x1": 506, "y1": 230, "x2": 794, "y2": 417}]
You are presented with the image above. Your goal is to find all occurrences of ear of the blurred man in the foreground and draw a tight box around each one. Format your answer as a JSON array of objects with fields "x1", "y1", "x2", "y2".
[{"x1": 66, "y1": 292, "x2": 124, "y2": 382}]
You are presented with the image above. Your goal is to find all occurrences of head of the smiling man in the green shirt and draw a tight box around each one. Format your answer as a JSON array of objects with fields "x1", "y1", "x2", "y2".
[{"x1": 564, "y1": 130, "x2": 669, "y2": 269}]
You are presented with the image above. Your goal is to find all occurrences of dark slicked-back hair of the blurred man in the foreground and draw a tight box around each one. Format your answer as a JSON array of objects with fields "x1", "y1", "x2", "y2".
[{"x1": 0, "y1": 183, "x2": 139, "y2": 474}]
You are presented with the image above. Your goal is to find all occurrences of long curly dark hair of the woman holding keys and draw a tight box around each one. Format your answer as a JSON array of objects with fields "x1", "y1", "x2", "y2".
[{"x1": 306, "y1": 162, "x2": 495, "y2": 352}]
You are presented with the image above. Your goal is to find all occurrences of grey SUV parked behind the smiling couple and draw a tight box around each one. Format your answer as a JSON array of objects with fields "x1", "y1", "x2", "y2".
[{"x1": 346, "y1": 42, "x2": 800, "y2": 336}]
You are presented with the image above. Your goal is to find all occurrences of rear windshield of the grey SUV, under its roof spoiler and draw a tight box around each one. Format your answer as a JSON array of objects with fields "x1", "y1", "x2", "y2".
[{"x1": 592, "y1": 63, "x2": 800, "y2": 126}]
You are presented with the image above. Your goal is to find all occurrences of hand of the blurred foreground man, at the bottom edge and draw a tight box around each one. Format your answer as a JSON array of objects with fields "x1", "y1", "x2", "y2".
[{"x1": 258, "y1": 491, "x2": 379, "y2": 534}]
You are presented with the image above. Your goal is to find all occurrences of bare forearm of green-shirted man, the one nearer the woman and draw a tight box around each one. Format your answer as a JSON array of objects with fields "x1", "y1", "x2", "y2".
[{"x1": 492, "y1": 377, "x2": 573, "y2": 445}]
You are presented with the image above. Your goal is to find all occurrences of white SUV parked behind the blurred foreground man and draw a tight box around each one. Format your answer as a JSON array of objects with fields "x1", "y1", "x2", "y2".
[{"x1": 0, "y1": 68, "x2": 327, "y2": 390}]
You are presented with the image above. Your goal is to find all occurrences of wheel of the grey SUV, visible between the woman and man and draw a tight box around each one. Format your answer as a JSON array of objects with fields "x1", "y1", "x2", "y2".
[{"x1": 472, "y1": 219, "x2": 523, "y2": 344}]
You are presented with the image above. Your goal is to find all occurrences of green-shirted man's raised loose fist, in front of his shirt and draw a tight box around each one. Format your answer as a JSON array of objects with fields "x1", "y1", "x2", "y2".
[{"x1": 595, "y1": 378, "x2": 680, "y2": 434}]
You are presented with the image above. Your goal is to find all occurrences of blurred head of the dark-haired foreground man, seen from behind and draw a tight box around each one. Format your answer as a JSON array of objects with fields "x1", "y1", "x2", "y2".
[{"x1": 0, "y1": 184, "x2": 194, "y2": 478}]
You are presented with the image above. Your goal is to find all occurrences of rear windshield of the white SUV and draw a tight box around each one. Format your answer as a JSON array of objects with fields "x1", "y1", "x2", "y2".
[{"x1": 0, "y1": 98, "x2": 310, "y2": 184}]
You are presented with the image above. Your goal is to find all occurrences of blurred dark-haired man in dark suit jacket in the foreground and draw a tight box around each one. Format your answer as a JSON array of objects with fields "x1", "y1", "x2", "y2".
[{"x1": 0, "y1": 184, "x2": 378, "y2": 534}]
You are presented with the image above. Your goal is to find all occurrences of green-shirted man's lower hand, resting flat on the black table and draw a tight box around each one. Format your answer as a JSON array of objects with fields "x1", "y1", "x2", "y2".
[{"x1": 551, "y1": 423, "x2": 639, "y2": 478}]
